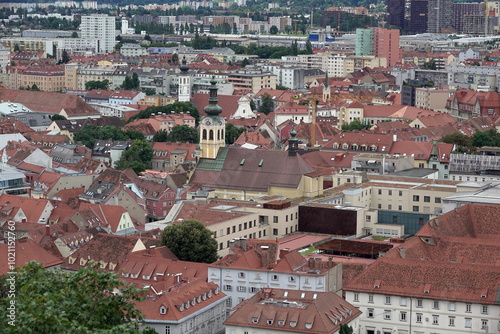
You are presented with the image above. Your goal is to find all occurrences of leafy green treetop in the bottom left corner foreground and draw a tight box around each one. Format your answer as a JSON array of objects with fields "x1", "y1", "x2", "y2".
[{"x1": 0, "y1": 262, "x2": 142, "y2": 334}]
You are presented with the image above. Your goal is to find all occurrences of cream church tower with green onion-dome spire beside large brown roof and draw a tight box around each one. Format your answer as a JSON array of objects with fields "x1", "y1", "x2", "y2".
[{"x1": 199, "y1": 77, "x2": 226, "y2": 159}]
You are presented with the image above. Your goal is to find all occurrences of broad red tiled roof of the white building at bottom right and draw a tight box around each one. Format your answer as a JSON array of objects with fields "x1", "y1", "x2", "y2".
[{"x1": 346, "y1": 204, "x2": 500, "y2": 304}]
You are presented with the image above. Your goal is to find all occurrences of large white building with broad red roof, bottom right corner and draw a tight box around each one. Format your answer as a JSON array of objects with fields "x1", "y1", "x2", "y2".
[{"x1": 345, "y1": 204, "x2": 500, "y2": 334}]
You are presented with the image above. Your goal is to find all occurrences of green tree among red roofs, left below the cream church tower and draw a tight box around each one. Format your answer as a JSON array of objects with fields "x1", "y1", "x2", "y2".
[{"x1": 116, "y1": 139, "x2": 153, "y2": 174}]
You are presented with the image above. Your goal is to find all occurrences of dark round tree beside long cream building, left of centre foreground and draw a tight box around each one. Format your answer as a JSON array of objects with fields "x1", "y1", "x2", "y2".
[{"x1": 162, "y1": 220, "x2": 218, "y2": 263}]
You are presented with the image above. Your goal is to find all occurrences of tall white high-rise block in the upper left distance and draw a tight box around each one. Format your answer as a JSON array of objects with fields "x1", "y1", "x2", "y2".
[{"x1": 80, "y1": 14, "x2": 116, "y2": 53}]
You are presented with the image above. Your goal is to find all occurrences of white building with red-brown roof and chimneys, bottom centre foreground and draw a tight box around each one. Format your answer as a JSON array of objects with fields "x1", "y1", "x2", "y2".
[{"x1": 208, "y1": 239, "x2": 342, "y2": 308}]
